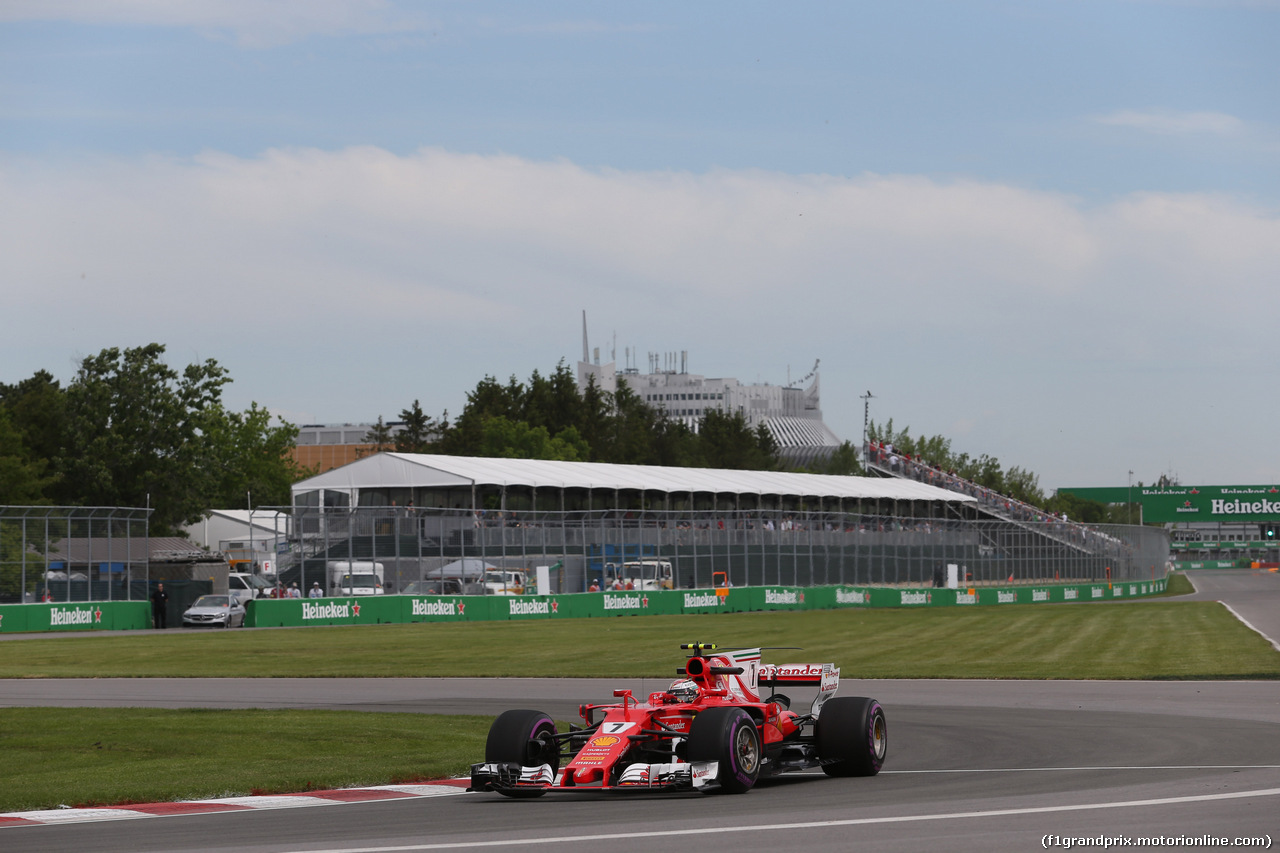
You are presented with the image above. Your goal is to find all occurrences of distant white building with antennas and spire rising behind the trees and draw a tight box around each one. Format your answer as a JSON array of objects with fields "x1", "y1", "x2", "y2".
[{"x1": 577, "y1": 313, "x2": 841, "y2": 465}]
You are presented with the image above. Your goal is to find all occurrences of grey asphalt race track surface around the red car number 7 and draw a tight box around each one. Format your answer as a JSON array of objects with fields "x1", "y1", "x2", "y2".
[{"x1": 0, "y1": 563, "x2": 1280, "y2": 853}]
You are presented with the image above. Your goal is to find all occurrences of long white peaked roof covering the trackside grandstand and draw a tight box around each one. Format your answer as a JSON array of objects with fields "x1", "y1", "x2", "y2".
[{"x1": 293, "y1": 453, "x2": 974, "y2": 503}]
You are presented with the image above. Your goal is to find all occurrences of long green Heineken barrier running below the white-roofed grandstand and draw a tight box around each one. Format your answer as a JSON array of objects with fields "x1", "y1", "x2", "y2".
[{"x1": 246, "y1": 578, "x2": 1167, "y2": 628}]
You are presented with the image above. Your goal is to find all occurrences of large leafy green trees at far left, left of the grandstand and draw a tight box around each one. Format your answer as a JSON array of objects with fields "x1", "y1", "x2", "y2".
[{"x1": 0, "y1": 343, "x2": 307, "y2": 534}]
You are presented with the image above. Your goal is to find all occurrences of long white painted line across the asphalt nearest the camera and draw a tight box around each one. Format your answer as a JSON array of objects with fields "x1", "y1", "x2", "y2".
[{"x1": 300, "y1": 788, "x2": 1280, "y2": 853}]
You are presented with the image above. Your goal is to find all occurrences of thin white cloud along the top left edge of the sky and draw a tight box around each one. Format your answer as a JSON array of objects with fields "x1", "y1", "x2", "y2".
[{"x1": 0, "y1": 0, "x2": 428, "y2": 47}]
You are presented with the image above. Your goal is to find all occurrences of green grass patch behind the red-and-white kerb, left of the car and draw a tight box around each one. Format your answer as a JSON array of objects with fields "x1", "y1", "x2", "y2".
[{"x1": 0, "y1": 708, "x2": 492, "y2": 812}]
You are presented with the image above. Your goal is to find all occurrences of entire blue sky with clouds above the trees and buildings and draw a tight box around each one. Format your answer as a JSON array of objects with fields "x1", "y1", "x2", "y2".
[{"x1": 0, "y1": 0, "x2": 1280, "y2": 489}]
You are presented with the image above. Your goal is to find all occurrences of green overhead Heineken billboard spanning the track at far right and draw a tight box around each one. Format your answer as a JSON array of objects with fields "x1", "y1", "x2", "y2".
[{"x1": 1059, "y1": 485, "x2": 1280, "y2": 524}]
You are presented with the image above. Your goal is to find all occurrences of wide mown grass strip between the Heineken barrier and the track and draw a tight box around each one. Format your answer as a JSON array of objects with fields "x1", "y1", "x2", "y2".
[{"x1": 0, "y1": 602, "x2": 1280, "y2": 679}]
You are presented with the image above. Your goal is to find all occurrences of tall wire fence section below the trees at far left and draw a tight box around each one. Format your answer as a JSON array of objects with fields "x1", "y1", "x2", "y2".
[{"x1": 0, "y1": 506, "x2": 151, "y2": 603}]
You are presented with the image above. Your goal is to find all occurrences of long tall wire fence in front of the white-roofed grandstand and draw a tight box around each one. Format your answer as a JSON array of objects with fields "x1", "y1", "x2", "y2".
[{"x1": 262, "y1": 507, "x2": 1169, "y2": 592}]
